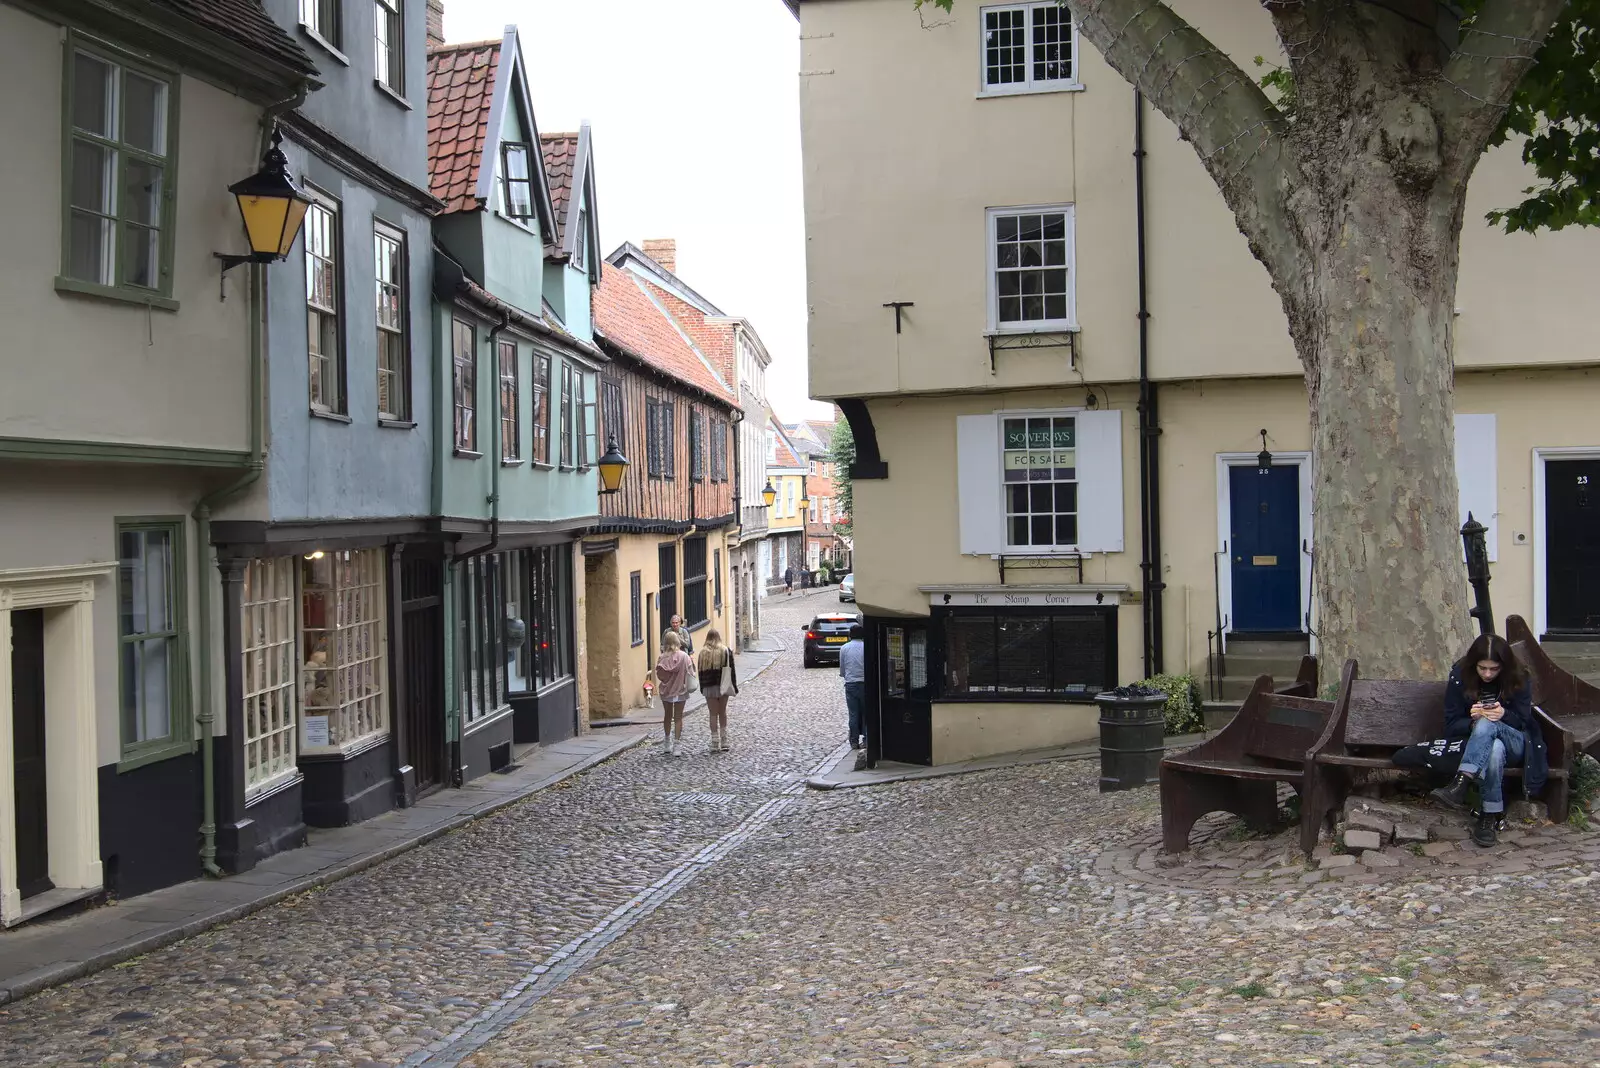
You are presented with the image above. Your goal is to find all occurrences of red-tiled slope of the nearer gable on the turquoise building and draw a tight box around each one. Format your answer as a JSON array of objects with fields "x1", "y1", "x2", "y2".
[{"x1": 427, "y1": 42, "x2": 501, "y2": 213}]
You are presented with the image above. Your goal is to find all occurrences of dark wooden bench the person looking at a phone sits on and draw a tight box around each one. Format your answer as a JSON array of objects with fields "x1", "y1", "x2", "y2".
[{"x1": 1301, "y1": 660, "x2": 1576, "y2": 852}]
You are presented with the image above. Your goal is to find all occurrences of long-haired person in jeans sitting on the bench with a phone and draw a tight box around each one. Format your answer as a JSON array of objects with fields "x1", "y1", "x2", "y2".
[{"x1": 1434, "y1": 635, "x2": 1549, "y2": 847}]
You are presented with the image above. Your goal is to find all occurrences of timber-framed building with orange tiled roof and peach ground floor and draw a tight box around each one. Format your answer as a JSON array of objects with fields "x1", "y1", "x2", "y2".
[{"x1": 582, "y1": 253, "x2": 739, "y2": 718}]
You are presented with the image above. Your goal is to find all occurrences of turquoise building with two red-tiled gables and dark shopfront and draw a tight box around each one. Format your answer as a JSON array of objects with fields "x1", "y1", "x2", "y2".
[{"x1": 429, "y1": 27, "x2": 608, "y2": 782}]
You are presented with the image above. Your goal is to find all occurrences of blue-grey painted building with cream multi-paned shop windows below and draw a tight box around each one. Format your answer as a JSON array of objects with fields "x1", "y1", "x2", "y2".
[{"x1": 211, "y1": 0, "x2": 443, "y2": 871}]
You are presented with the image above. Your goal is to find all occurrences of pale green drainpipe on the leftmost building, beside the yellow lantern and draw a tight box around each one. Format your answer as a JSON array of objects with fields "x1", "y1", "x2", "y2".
[{"x1": 192, "y1": 85, "x2": 310, "y2": 876}]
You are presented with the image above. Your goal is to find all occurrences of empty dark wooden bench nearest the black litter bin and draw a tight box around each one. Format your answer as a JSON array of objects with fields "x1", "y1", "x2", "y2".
[{"x1": 1162, "y1": 657, "x2": 1336, "y2": 852}]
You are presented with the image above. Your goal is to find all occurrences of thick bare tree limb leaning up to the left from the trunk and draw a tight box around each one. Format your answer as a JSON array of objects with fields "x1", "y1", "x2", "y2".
[{"x1": 1066, "y1": 0, "x2": 1304, "y2": 281}]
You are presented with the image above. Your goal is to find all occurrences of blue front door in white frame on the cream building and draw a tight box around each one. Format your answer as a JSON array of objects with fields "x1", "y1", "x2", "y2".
[{"x1": 1227, "y1": 465, "x2": 1301, "y2": 632}]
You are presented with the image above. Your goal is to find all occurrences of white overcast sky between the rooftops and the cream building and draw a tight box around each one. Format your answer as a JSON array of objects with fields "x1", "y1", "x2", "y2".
[{"x1": 445, "y1": 0, "x2": 832, "y2": 422}]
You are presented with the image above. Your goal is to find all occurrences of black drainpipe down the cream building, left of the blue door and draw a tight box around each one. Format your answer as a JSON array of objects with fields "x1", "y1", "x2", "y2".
[{"x1": 1133, "y1": 90, "x2": 1166, "y2": 678}]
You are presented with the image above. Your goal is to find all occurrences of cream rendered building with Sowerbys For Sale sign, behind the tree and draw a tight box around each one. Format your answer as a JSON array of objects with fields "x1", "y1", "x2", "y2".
[{"x1": 787, "y1": 0, "x2": 1600, "y2": 763}]
